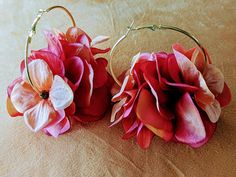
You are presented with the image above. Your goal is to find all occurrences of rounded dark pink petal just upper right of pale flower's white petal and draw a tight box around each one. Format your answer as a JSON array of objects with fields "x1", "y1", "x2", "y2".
[{"x1": 65, "y1": 56, "x2": 84, "y2": 89}]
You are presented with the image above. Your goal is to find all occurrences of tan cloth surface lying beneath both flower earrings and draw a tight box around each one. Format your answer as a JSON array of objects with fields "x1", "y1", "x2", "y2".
[{"x1": 0, "y1": 0, "x2": 236, "y2": 177}]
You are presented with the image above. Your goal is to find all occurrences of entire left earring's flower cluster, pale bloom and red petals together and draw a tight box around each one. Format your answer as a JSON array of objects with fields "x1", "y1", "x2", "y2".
[{"x1": 7, "y1": 27, "x2": 111, "y2": 137}]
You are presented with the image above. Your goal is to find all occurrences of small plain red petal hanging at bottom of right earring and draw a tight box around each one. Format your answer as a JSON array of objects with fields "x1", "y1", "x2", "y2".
[{"x1": 136, "y1": 126, "x2": 154, "y2": 149}]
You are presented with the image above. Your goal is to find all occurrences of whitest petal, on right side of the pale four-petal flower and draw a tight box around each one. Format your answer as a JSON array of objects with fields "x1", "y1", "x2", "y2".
[{"x1": 49, "y1": 75, "x2": 74, "y2": 110}]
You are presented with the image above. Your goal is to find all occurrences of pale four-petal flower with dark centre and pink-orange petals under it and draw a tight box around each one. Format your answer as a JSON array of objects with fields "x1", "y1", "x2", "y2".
[{"x1": 7, "y1": 59, "x2": 73, "y2": 137}]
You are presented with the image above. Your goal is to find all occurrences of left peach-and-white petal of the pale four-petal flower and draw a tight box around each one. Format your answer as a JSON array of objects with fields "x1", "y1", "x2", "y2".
[{"x1": 10, "y1": 82, "x2": 41, "y2": 113}]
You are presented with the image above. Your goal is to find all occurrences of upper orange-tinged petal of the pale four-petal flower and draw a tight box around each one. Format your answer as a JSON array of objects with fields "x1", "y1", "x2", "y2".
[{"x1": 23, "y1": 59, "x2": 53, "y2": 92}]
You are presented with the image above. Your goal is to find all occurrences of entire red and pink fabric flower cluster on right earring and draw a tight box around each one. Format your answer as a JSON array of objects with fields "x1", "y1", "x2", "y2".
[{"x1": 111, "y1": 44, "x2": 231, "y2": 148}]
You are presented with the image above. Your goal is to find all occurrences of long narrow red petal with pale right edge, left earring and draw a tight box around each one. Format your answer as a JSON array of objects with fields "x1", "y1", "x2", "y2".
[{"x1": 75, "y1": 61, "x2": 94, "y2": 107}]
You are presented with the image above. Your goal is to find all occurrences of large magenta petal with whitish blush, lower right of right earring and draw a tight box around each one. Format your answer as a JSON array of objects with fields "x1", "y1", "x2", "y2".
[{"x1": 175, "y1": 93, "x2": 206, "y2": 144}]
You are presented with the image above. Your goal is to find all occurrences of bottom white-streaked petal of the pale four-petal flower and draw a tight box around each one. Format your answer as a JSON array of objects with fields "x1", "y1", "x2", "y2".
[{"x1": 24, "y1": 100, "x2": 54, "y2": 132}]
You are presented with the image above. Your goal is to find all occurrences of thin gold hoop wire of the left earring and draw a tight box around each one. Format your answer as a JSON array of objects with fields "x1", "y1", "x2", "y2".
[{"x1": 24, "y1": 6, "x2": 76, "y2": 87}]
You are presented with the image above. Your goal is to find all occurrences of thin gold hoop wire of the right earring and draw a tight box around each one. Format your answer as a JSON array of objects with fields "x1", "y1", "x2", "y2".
[{"x1": 109, "y1": 21, "x2": 207, "y2": 86}]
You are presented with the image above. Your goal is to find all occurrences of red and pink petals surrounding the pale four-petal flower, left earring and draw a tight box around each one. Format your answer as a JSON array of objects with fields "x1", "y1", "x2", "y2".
[{"x1": 7, "y1": 27, "x2": 111, "y2": 136}]
